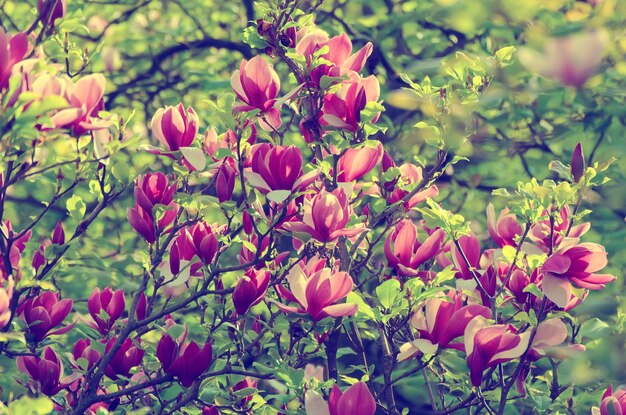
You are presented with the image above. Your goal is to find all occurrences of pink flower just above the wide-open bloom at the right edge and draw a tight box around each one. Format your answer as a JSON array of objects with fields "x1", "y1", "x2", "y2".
[{"x1": 528, "y1": 205, "x2": 591, "y2": 252}]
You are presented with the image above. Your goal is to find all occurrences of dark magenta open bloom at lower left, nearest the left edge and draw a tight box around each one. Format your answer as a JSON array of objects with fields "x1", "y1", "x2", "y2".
[{"x1": 17, "y1": 291, "x2": 75, "y2": 342}]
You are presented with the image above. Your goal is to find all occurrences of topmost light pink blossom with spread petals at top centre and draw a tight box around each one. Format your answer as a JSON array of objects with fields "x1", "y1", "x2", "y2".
[{"x1": 296, "y1": 30, "x2": 374, "y2": 86}]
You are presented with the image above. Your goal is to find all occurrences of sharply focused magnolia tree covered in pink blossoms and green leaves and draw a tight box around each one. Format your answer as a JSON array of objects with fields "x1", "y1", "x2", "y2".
[{"x1": 0, "y1": 1, "x2": 626, "y2": 415}]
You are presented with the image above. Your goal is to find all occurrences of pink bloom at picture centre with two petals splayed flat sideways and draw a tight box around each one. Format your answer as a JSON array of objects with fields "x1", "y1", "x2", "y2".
[{"x1": 283, "y1": 188, "x2": 363, "y2": 242}]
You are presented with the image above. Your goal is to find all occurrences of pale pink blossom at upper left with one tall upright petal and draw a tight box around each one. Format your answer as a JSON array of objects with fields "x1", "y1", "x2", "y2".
[{"x1": 50, "y1": 74, "x2": 108, "y2": 136}]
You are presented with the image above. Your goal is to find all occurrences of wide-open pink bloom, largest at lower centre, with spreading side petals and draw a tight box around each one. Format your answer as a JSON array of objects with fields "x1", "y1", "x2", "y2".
[{"x1": 276, "y1": 262, "x2": 358, "y2": 321}]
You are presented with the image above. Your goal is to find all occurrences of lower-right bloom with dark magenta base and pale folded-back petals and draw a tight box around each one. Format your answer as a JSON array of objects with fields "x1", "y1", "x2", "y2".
[{"x1": 464, "y1": 316, "x2": 530, "y2": 386}]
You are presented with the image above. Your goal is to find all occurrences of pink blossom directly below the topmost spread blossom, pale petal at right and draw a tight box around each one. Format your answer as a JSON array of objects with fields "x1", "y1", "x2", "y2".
[{"x1": 320, "y1": 75, "x2": 380, "y2": 133}]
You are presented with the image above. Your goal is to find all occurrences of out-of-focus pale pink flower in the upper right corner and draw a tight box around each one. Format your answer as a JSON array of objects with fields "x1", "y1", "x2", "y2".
[{"x1": 519, "y1": 30, "x2": 608, "y2": 88}]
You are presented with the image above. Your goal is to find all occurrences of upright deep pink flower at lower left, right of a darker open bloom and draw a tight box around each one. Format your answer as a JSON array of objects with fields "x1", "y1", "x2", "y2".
[{"x1": 87, "y1": 287, "x2": 126, "y2": 334}]
